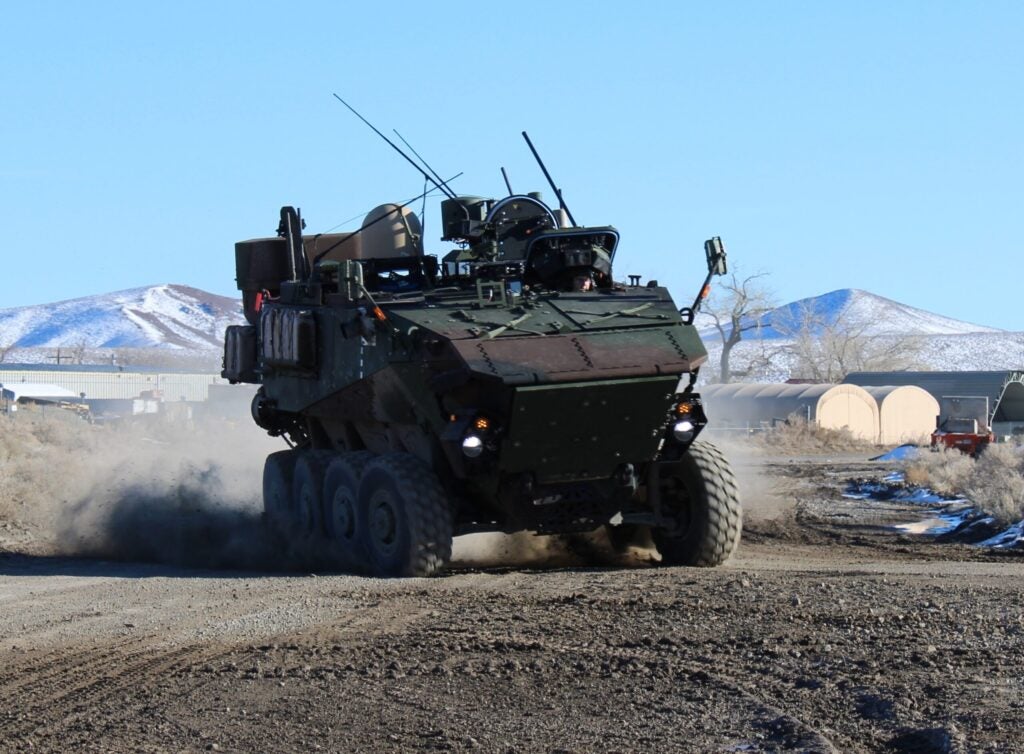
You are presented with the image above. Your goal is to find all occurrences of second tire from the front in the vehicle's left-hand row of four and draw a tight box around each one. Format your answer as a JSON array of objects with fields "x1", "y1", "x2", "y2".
[{"x1": 322, "y1": 451, "x2": 374, "y2": 570}]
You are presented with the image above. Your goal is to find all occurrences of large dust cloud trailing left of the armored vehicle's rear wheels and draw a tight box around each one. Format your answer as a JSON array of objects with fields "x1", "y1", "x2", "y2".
[{"x1": 0, "y1": 410, "x2": 284, "y2": 570}]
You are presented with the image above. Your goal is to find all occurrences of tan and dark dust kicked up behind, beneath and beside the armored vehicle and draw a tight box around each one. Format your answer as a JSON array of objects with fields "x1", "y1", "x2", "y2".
[{"x1": 0, "y1": 410, "x2": 796, "y2": 571}]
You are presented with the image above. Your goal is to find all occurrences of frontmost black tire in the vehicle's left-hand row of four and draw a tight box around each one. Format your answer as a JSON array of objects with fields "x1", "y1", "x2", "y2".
[{"x1": 357, "y1": 453, "x2": 454, "y2": 577}]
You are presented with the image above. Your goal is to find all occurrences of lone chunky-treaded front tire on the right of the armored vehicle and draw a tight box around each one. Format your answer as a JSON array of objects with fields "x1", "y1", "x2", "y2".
[{"x1": 652, "y1": 441, "x2": 742, "y2": 567}]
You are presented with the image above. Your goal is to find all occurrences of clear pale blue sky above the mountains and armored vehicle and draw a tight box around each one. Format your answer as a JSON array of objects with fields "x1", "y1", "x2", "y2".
[{"x1": 0, "y1": 0, "x2": 1024, "y2": 330}]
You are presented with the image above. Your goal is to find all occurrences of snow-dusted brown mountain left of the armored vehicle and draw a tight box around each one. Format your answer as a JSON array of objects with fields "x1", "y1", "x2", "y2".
[{"x1": 0, "y1": 285, "x2": 244, "y2": 351}]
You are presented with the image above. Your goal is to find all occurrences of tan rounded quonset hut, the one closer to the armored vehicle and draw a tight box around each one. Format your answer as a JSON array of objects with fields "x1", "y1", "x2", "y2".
[{"x1": 700, "y1": 382, "x2": 880, "y2": 443}]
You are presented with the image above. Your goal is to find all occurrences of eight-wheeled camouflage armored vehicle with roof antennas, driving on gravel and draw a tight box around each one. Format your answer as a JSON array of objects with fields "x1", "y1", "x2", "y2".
[{"x1": 223, "y1": 104, "x2": 740, "y2": 576}]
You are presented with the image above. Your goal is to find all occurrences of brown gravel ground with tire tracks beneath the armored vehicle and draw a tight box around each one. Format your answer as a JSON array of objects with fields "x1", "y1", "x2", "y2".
[{"x1": 0, "y1": 450, "x2": 1024, "y2": 754}]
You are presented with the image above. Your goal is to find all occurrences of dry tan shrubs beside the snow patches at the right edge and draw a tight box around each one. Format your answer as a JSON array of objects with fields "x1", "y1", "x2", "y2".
[{"x1": 904, "y1": 445, "x2": 1024, "y2": 523}]
